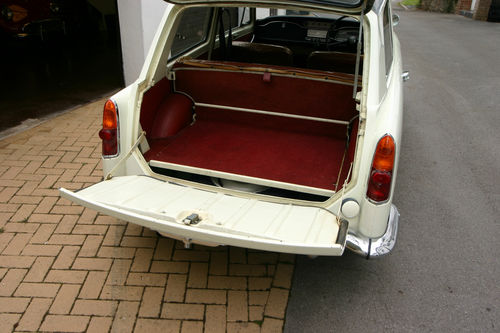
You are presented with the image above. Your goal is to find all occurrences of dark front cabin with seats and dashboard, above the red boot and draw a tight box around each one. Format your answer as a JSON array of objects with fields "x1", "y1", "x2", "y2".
[{"x1": 203, "y1": 10, "x2": 359, "y2": 74}]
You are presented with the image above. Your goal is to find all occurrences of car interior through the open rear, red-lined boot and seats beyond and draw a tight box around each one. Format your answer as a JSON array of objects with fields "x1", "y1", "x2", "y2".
[{"x1": 140, "y1": 8, "x2": 362, "y2": 200}]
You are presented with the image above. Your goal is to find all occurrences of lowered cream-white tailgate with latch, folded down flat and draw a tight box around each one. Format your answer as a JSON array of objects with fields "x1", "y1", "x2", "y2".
[{"x1": 60, "y1": 176, "x2": 347, "y2": 256}]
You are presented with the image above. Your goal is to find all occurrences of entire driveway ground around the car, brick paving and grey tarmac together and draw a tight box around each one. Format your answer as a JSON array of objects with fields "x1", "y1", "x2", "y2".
[{"x1": 0, "y1": 6, "x2": 500, "y2": 332}]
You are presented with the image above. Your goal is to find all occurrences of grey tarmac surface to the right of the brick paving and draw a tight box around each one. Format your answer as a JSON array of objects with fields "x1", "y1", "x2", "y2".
[{"x1": 285, "y1": 5, "x2": 500, "y2": 332}]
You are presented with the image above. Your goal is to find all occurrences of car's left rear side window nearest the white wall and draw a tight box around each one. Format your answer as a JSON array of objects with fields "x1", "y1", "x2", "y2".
[{"x1": 170, "y1": 7, "x2": 212, "y2": 58}]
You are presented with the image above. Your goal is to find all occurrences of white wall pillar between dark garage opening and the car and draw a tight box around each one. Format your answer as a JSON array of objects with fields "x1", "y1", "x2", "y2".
[{"x1": 117, "y1": 0, "x2": 168, "y2": 85}]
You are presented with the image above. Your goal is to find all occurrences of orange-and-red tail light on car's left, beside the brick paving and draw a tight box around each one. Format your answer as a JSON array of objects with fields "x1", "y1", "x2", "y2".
[{"x1": 99, "y1": 100, "x2": 119, "y2": 157}]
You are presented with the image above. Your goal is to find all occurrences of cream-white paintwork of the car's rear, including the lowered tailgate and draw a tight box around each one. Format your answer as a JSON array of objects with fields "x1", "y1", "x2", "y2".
[{"x1": 62, "y1": 0, "x2": 403, "y2": 255}]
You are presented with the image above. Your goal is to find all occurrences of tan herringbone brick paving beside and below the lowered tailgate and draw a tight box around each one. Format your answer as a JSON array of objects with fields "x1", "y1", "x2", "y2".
[{"x1": 0, "y1": 101, "x2": 295, "y2": 333}]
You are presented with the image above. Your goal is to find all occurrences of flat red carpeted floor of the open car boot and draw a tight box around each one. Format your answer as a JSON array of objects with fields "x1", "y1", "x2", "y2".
[{"x1": 145, "y1": 119, "x2": 346, "y2": 190}]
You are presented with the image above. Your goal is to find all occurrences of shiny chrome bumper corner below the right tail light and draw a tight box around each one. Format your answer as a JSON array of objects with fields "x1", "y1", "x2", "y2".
[{"x1": 346, "y1": 205, "x2": 399, "y2": 259}]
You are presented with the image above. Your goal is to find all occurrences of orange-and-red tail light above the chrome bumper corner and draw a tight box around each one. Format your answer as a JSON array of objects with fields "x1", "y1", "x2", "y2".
[{"x1": 366, "y1": 134, "x2": 396, "y2": 202}]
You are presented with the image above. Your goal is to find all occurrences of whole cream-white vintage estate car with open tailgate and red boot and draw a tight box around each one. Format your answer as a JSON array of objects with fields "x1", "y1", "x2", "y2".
[{"x1": 60, "y1": 0, "x2": 407, "y2": 258}]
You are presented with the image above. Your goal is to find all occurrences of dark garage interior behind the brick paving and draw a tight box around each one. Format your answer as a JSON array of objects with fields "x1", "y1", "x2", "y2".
[{"x1": 0, "y1": 0, "x2": 124, "y2": 137}]
